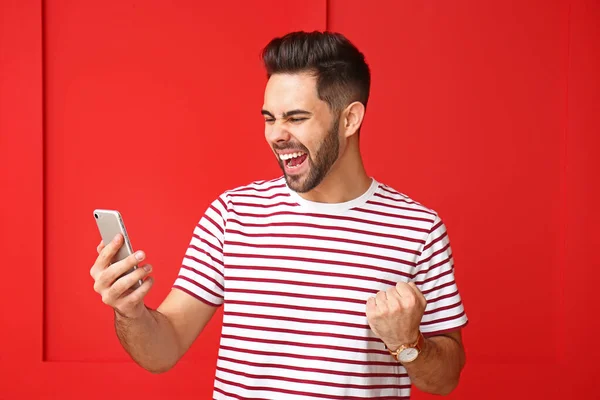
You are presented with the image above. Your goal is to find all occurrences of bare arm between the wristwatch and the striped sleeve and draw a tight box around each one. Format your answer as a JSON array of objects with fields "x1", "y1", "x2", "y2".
[{"x1": 404, "y1": 336, "x2": 465, "y2": 395}]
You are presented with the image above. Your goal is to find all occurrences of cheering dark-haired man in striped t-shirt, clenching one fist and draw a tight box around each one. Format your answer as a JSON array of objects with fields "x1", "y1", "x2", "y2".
[{"x1": 91, "y1": 32, "x2": 467, "y2": 399}]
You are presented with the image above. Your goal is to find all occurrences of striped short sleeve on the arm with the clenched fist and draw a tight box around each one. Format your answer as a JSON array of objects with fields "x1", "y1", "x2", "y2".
[{"x1": 414, "y1": 216, "x2": 467, "y2": 336}]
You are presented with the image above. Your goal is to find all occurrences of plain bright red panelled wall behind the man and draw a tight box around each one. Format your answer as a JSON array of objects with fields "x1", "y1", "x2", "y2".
[{"x1": 0, "y1": 0, "x2": 600, "y2": 399}]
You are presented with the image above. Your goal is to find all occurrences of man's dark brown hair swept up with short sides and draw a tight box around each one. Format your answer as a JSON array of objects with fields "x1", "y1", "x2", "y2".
[{"x1": 262, "y1": 31, "x2": 371, "y2": 112}]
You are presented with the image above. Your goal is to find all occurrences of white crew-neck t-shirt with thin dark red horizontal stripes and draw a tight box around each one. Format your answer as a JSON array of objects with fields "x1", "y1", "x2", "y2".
[{"x1": 174, "y1": 177, "x2": 467, "y2": 399}]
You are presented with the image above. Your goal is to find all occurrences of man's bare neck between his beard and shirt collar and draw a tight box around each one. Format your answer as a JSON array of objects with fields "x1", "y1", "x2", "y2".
[{"x1": 299, "y1": 143, "x2": 371, "y2": 203}]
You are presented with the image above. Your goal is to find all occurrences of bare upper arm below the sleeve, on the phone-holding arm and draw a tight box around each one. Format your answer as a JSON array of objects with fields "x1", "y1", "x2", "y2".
[{"x1": 157, "y1": 288, "x2": 218, "y2": 357}]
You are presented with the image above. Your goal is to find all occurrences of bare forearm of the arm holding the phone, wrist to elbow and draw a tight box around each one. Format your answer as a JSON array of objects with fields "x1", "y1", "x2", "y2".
[{"x1": 115, "y1": 308, "x2": 180, "y2": 373}]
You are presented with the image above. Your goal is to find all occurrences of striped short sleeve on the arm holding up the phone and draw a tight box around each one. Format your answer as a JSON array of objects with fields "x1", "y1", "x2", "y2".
[{"x1": 173, "y1": 195, "x2": 227, "y2": 307}]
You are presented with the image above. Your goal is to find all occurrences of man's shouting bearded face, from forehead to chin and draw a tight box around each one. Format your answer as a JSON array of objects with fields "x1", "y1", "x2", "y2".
[{"x1": 262, "y1": 74, "x2": 340, "y2": 193}]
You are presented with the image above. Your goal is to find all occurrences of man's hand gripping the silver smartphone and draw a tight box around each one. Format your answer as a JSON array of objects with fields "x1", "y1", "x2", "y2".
[{"x1": 90, "y1": 234, "x2": 153, "y2": 318}]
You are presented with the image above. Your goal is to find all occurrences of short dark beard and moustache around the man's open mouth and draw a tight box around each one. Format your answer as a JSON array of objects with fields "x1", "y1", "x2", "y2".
[{"x1": 277, "y1": 119, "x2": 340, "y2": 193}]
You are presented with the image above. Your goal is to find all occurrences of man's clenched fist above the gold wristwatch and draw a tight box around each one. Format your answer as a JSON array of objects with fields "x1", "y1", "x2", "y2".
[{"x1": 367, "y1": 282, "x2": 427, "y2": 351}]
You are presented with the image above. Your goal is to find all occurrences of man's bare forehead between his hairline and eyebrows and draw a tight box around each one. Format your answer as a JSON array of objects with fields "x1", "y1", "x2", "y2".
[{"x1": 263, "y1": 73, "x2": 326, "y2": 115}]
